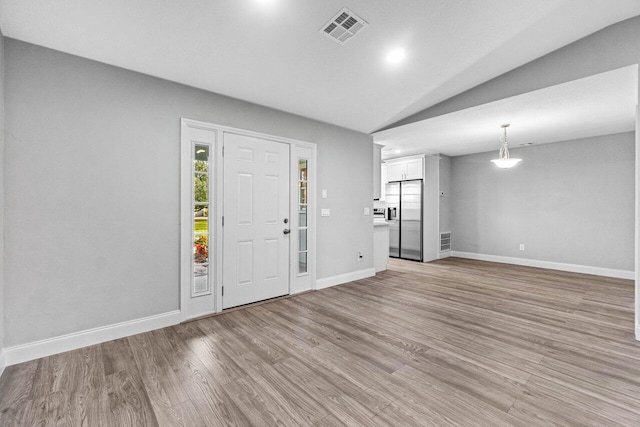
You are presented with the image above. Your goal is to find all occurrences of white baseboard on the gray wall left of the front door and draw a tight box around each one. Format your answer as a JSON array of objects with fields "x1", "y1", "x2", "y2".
[{"x1": 4, "y1": 310, "x2": 181, "y2": 366}]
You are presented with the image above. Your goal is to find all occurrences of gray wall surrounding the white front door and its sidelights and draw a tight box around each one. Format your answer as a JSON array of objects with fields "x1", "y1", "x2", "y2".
[{"x1": 5, "y1": 39, "x2": 373, "y2": 346}]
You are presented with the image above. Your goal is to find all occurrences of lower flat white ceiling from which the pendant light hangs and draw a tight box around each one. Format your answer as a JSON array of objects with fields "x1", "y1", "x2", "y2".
[{"x1": 374, "y1": 65, "x2": 638, "y2": 159}]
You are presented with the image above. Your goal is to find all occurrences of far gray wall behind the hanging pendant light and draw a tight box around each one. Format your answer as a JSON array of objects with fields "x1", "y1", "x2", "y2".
[{"x1": 451, "y1": 132, "x2": 635, "y2": 271}]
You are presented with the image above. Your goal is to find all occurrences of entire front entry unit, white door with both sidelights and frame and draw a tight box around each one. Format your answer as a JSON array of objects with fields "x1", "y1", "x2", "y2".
[{"x1": 180, "y1": 119, "x2": 316, "y2": 320}]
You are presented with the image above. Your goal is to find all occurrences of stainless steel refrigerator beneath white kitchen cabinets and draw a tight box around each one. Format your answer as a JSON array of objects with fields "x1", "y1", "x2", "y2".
[{"x1": 385, "y1": 179, "x2": 422, "y2": 261}]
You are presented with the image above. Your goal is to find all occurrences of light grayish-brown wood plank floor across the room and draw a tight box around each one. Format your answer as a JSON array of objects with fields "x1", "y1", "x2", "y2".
[{"x1": 0, "y1": 258, "x2": 640, "y2": 426}]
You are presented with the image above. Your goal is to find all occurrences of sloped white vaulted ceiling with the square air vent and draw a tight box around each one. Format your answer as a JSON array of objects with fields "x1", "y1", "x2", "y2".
[{"x1": 0, "y1": 0, "x2": 640, "y2": 133}]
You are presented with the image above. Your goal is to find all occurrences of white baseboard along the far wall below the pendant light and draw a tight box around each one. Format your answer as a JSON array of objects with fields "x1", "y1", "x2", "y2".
[{"x1": 451, "y1": 251, "x2": 636, "y2": 280}]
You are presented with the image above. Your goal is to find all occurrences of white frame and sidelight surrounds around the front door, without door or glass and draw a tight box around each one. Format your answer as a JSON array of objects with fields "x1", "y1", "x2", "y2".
[{"x1": 179, "y1": 118, "x2": 317, "y2": 321}]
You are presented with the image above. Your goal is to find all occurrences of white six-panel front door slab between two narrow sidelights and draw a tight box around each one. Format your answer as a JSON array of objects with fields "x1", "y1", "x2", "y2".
[{"x1": 222, "y1": 132, "x2": 290, "y2": 308}]
